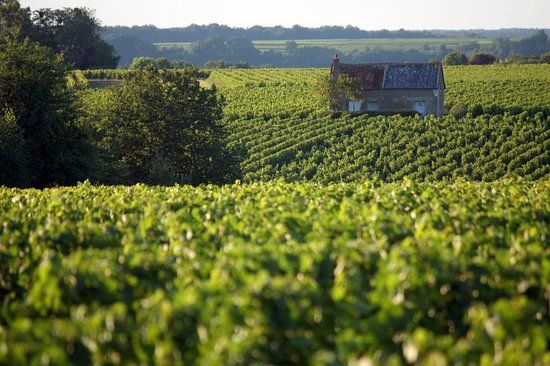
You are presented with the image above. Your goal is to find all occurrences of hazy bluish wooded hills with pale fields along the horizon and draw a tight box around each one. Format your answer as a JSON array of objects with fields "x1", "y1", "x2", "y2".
[{"x1": 102, "y1": 24, "x2": 550, "y2": 67}]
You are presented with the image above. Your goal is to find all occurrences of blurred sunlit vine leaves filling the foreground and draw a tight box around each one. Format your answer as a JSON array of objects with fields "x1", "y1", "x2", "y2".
[{"x1": 0, "y1": 180, "x2": 550, "y2": 366}]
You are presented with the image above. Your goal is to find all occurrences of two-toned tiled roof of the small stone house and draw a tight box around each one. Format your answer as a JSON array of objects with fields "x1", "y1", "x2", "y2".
[{"x1": 340, "y1": 64, "x2": 443, "y2": 90}]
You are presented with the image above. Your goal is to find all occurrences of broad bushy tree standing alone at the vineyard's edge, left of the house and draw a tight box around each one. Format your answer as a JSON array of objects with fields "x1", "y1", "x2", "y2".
[{"x1": 88, "y1": 68, "x2": 238, "y2": 184}]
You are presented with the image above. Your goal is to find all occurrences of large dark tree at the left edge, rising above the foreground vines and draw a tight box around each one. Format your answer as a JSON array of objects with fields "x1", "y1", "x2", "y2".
[{"x1": 0, "y1": 37, "x2": 91, "y2": 187}]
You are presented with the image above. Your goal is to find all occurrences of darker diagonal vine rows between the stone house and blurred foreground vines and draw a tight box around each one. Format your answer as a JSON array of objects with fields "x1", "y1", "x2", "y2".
[{"x1": 229, "y1": 114, "x2": 550, "y2": 183}]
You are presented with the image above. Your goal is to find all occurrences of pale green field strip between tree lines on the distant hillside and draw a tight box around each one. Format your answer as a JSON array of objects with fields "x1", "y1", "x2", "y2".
[{"x1": 155, "y1": 38, "x2": 493, "y2": 53}]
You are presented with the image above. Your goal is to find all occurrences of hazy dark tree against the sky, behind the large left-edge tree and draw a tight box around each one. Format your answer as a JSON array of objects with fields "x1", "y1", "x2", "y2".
[{"x1": 32, "y1": 8, "x2": 118, "y2": 69}]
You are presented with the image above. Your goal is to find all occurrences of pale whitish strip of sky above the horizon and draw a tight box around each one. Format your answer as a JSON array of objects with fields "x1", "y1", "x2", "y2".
[{"x1": 20, "y1": 0, "x2": 550, "y2": 30}]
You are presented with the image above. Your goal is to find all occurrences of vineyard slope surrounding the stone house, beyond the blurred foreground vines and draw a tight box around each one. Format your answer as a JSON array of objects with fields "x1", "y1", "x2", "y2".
[{"x1": 209, "y1": 65, "x2": 550, "y2": 183}]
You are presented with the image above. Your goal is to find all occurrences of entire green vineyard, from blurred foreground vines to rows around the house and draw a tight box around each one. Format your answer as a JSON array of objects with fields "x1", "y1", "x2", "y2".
[{"x1": 0, "y1": 65, "x2": 550, "y2": 365}]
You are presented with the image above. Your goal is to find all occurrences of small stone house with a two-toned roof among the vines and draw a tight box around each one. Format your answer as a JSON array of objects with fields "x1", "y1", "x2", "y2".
[{"x1": 330, "y1": 55, "x2": 445, "y2": 117}]
